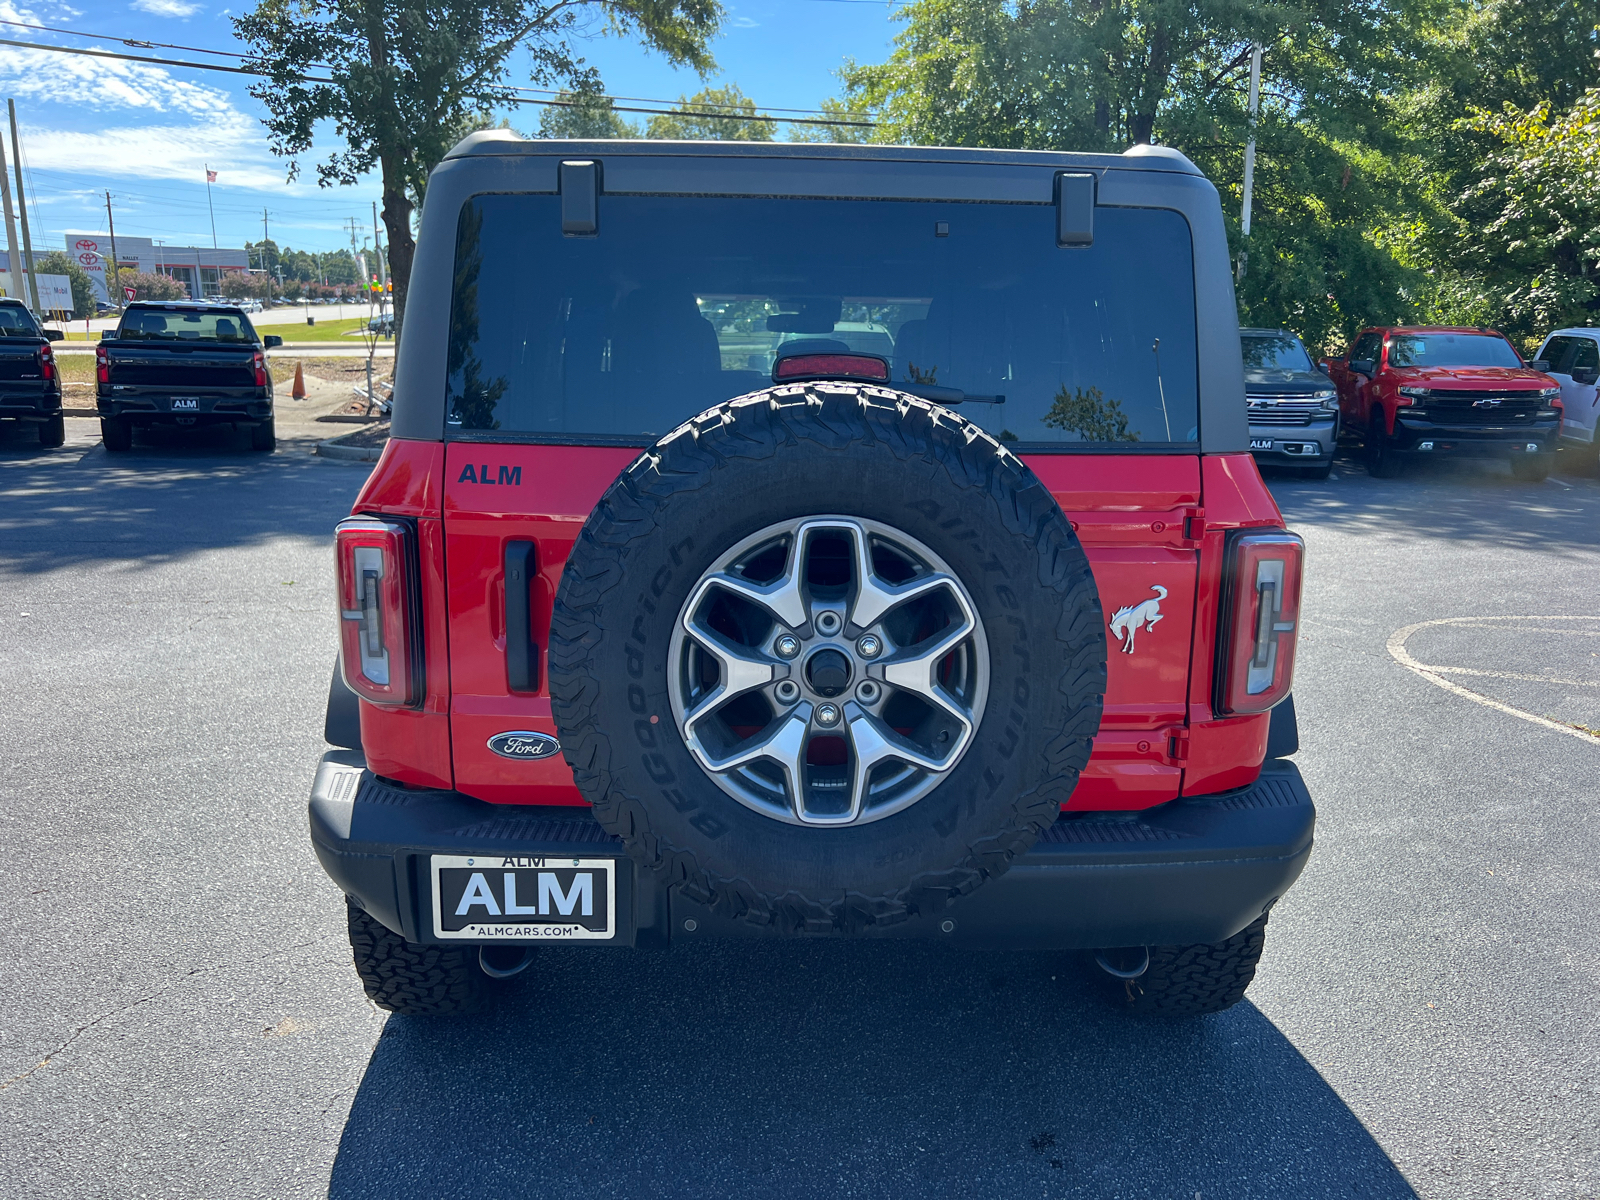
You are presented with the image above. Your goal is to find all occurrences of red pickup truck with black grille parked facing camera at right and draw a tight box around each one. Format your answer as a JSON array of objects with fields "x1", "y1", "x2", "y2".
[{"x1": 1322, "y1": 325, "x2": 1562, "y2": 482}]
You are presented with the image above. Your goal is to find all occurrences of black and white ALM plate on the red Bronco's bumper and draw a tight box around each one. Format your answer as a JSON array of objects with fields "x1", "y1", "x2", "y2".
[{"x1": 432, "y1": 854, "x2": 616, "y2": 941}]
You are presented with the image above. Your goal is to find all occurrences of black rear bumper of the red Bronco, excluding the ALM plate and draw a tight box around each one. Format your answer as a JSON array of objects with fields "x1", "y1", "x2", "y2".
[{"x1": 310, "y1": 750, "x2": 1317, "y2": 949}]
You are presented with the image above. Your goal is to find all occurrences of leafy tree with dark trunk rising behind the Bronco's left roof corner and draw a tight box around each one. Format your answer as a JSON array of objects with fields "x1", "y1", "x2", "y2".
[{"x1": 234, "y1": 0, "x2": 722, "y2": 334}]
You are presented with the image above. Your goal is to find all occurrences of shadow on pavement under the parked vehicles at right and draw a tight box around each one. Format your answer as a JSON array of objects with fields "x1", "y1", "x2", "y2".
[{"x1": 1261, "y1": 458, "x2": 1600, "y2": 554}]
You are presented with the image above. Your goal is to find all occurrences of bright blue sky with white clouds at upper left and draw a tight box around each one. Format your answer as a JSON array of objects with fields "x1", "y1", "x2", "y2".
[{"x1": 0, "y1": 0, "x2": 899, "y2": 250}]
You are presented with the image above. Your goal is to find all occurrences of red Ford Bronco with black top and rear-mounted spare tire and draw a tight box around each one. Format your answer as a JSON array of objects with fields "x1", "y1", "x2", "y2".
[{"x1": 310, "y1": 133, "x2": 1315, "y2": 1013}]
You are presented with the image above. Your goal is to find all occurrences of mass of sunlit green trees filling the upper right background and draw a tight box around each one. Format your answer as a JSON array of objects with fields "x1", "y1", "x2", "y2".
[{"x1": 843, "y1": 0, "x2": 1600, "y2": 346}]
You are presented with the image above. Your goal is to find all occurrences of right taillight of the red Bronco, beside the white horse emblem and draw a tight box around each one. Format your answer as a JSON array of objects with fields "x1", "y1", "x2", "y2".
[{"x1": 1216, "y1": 530, "x2": 1306, "y2": 714}]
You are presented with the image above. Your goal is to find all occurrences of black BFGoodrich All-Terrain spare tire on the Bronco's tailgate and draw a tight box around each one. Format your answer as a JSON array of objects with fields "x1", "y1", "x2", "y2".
[{"x1": 550, "y1": 384, "x2": 1106, "y2": 933}]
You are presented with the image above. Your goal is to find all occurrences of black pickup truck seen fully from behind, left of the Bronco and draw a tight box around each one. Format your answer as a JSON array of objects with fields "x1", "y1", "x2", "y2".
[{"x1": 94, "y1": 301, "x2": 283, "y2": 451}]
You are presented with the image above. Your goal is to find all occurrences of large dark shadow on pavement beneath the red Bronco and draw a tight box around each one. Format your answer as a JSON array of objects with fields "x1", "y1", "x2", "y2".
[{"x1": 330, "y1": 942, "x2": 1414, "y2": 1200}]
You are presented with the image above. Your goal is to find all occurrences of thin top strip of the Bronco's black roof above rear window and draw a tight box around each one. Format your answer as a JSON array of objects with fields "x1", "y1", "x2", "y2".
[{"x1": 445, "y1": 130, "x2": 1202, "y2": 174}]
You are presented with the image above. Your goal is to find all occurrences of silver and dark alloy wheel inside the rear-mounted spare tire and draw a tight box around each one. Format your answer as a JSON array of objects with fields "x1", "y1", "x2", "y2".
[{"x1": 667, "y1": 517, "x2": 989, "y2": 826}]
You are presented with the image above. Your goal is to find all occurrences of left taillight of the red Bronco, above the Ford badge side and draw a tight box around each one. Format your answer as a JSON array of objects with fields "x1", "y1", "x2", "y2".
[{"x1": 334, "y1": 517, "x2": 422, "y2": 706}]
